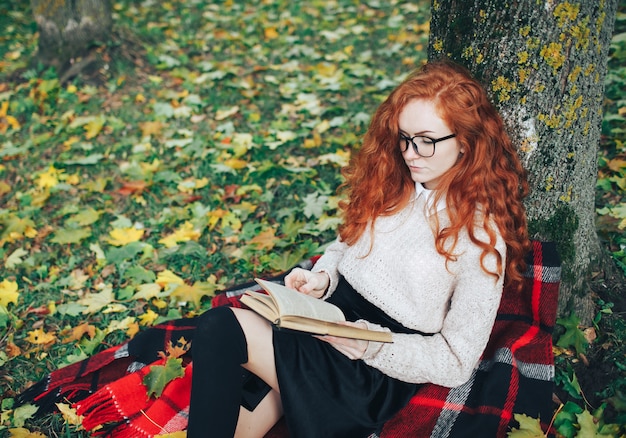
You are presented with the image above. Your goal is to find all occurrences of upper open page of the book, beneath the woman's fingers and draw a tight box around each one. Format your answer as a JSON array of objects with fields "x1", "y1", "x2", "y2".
[{"x1": 256, "y1": 278, "x2": 346, "y2": 322}]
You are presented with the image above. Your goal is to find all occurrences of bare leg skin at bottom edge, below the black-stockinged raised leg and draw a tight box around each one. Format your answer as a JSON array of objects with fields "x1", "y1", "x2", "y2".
[{"x1": 235, "y1": 390, "x2": 283, "y2": 438}]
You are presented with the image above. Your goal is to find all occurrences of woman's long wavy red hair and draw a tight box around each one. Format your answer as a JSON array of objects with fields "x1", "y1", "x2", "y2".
[{"x1": 339, "y1": 61, "x2": 530, "y2": 289}]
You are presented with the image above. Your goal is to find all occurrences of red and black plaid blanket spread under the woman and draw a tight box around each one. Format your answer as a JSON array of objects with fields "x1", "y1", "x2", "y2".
[{"x1": 18, "y1": 241, "x2": 560, "y2": 438}]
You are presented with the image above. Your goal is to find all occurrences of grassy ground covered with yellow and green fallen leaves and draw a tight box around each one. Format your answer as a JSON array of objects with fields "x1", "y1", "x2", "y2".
[{"x1": 0, "y1": 0, "x2": 626, "y2": 437}]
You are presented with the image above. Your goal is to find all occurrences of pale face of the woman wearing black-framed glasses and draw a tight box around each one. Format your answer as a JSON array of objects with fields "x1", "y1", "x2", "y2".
[{"x1": 398, "y1": 100, "x2": 464, "y2": 190}]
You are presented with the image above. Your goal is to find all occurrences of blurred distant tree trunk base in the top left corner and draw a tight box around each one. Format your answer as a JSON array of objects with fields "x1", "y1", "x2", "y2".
[{"x1": 31, "y1": 0, "x2": 112, "y2": 75}]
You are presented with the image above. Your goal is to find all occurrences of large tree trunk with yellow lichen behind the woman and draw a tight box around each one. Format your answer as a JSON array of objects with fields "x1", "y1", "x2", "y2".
[{"x1": 428, "y1": 0, "x2": 618, "y2": 322}]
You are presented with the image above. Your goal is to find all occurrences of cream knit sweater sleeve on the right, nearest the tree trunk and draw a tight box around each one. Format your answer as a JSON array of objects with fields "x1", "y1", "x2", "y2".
[{"x1": 363, "y1": 241, "x2": 505, "y2": 387}]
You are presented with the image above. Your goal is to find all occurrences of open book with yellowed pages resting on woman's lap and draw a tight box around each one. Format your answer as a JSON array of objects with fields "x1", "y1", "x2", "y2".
[{"x1": 241, "y1": 278, "x2": 393, "y2": 342}]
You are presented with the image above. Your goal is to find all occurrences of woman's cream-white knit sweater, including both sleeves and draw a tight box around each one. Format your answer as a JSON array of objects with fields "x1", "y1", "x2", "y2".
[{"x1": 313, "y1": 184, "x2": 506, "y2": 387}]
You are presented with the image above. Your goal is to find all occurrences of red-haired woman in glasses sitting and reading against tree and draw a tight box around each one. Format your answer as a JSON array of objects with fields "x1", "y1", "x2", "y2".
[{"x1": 188, "y1": 61, "x2": 529, "y2": 438}]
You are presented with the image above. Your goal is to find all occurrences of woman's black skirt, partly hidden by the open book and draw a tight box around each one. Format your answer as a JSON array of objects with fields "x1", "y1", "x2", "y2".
[{"x1": 273, "y1": 279, "x2": 419, "y2": 438}]
